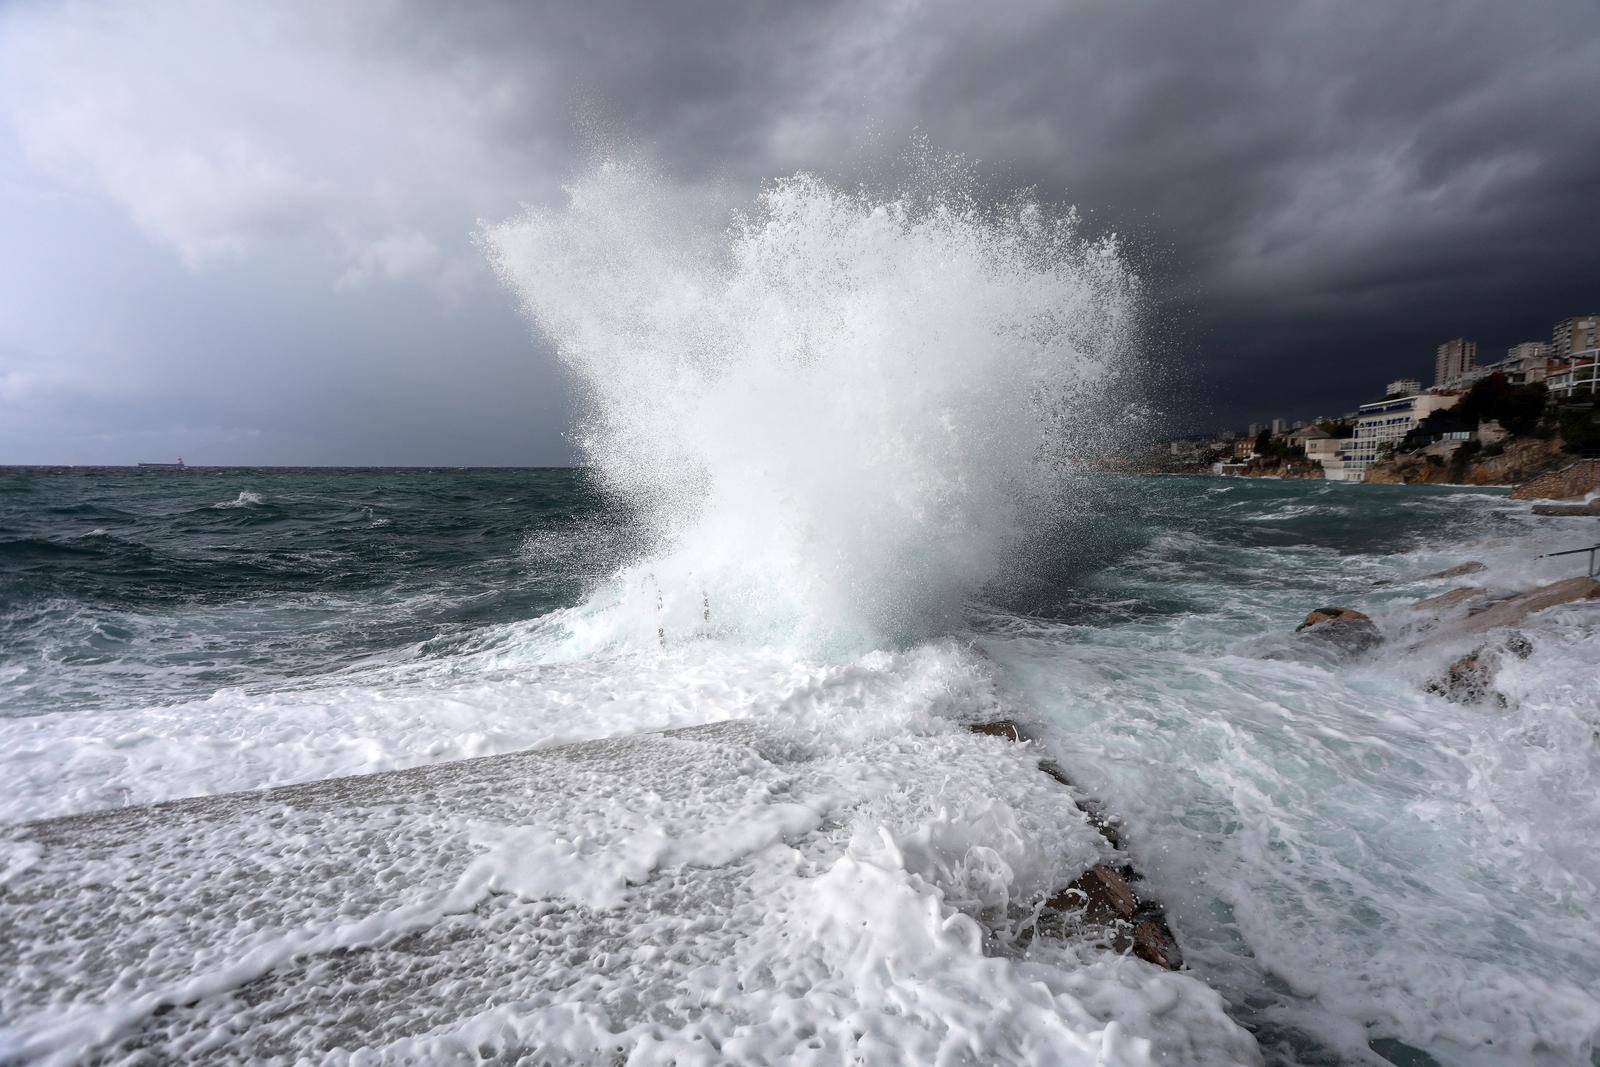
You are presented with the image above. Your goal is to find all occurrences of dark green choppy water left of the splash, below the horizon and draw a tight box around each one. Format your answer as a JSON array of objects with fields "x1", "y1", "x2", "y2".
[{"x1": 0, "y1": 467, "x2": 629, "y2": 715}]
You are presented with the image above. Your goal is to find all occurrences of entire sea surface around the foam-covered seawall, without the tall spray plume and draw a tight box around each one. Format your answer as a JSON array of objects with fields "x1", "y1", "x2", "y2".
[{"x1": 0, "y1": 469, "x2": 1600, "y2": 1064}]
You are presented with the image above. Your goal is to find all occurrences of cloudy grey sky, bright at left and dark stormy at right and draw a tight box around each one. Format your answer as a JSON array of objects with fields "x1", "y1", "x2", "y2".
[{"x1": 0, "y1": 0, "x2": 1600, "y2": 464}]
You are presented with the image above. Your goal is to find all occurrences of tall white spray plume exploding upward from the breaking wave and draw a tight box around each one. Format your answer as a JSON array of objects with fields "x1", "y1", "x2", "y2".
[{"x1": 485, "y1": 160, "x2": 1139, "y2": 645}]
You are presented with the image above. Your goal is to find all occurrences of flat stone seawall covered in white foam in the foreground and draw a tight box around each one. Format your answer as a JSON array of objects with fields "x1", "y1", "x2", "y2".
[{"x1": 0, "y1": 721, "x2": 1261, "y2": 1065}]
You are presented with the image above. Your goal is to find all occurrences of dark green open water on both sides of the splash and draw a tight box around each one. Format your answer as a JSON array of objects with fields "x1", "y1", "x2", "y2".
[{"x1": 0, "y1": 467, "x2": 1510, "y2": 715}]
